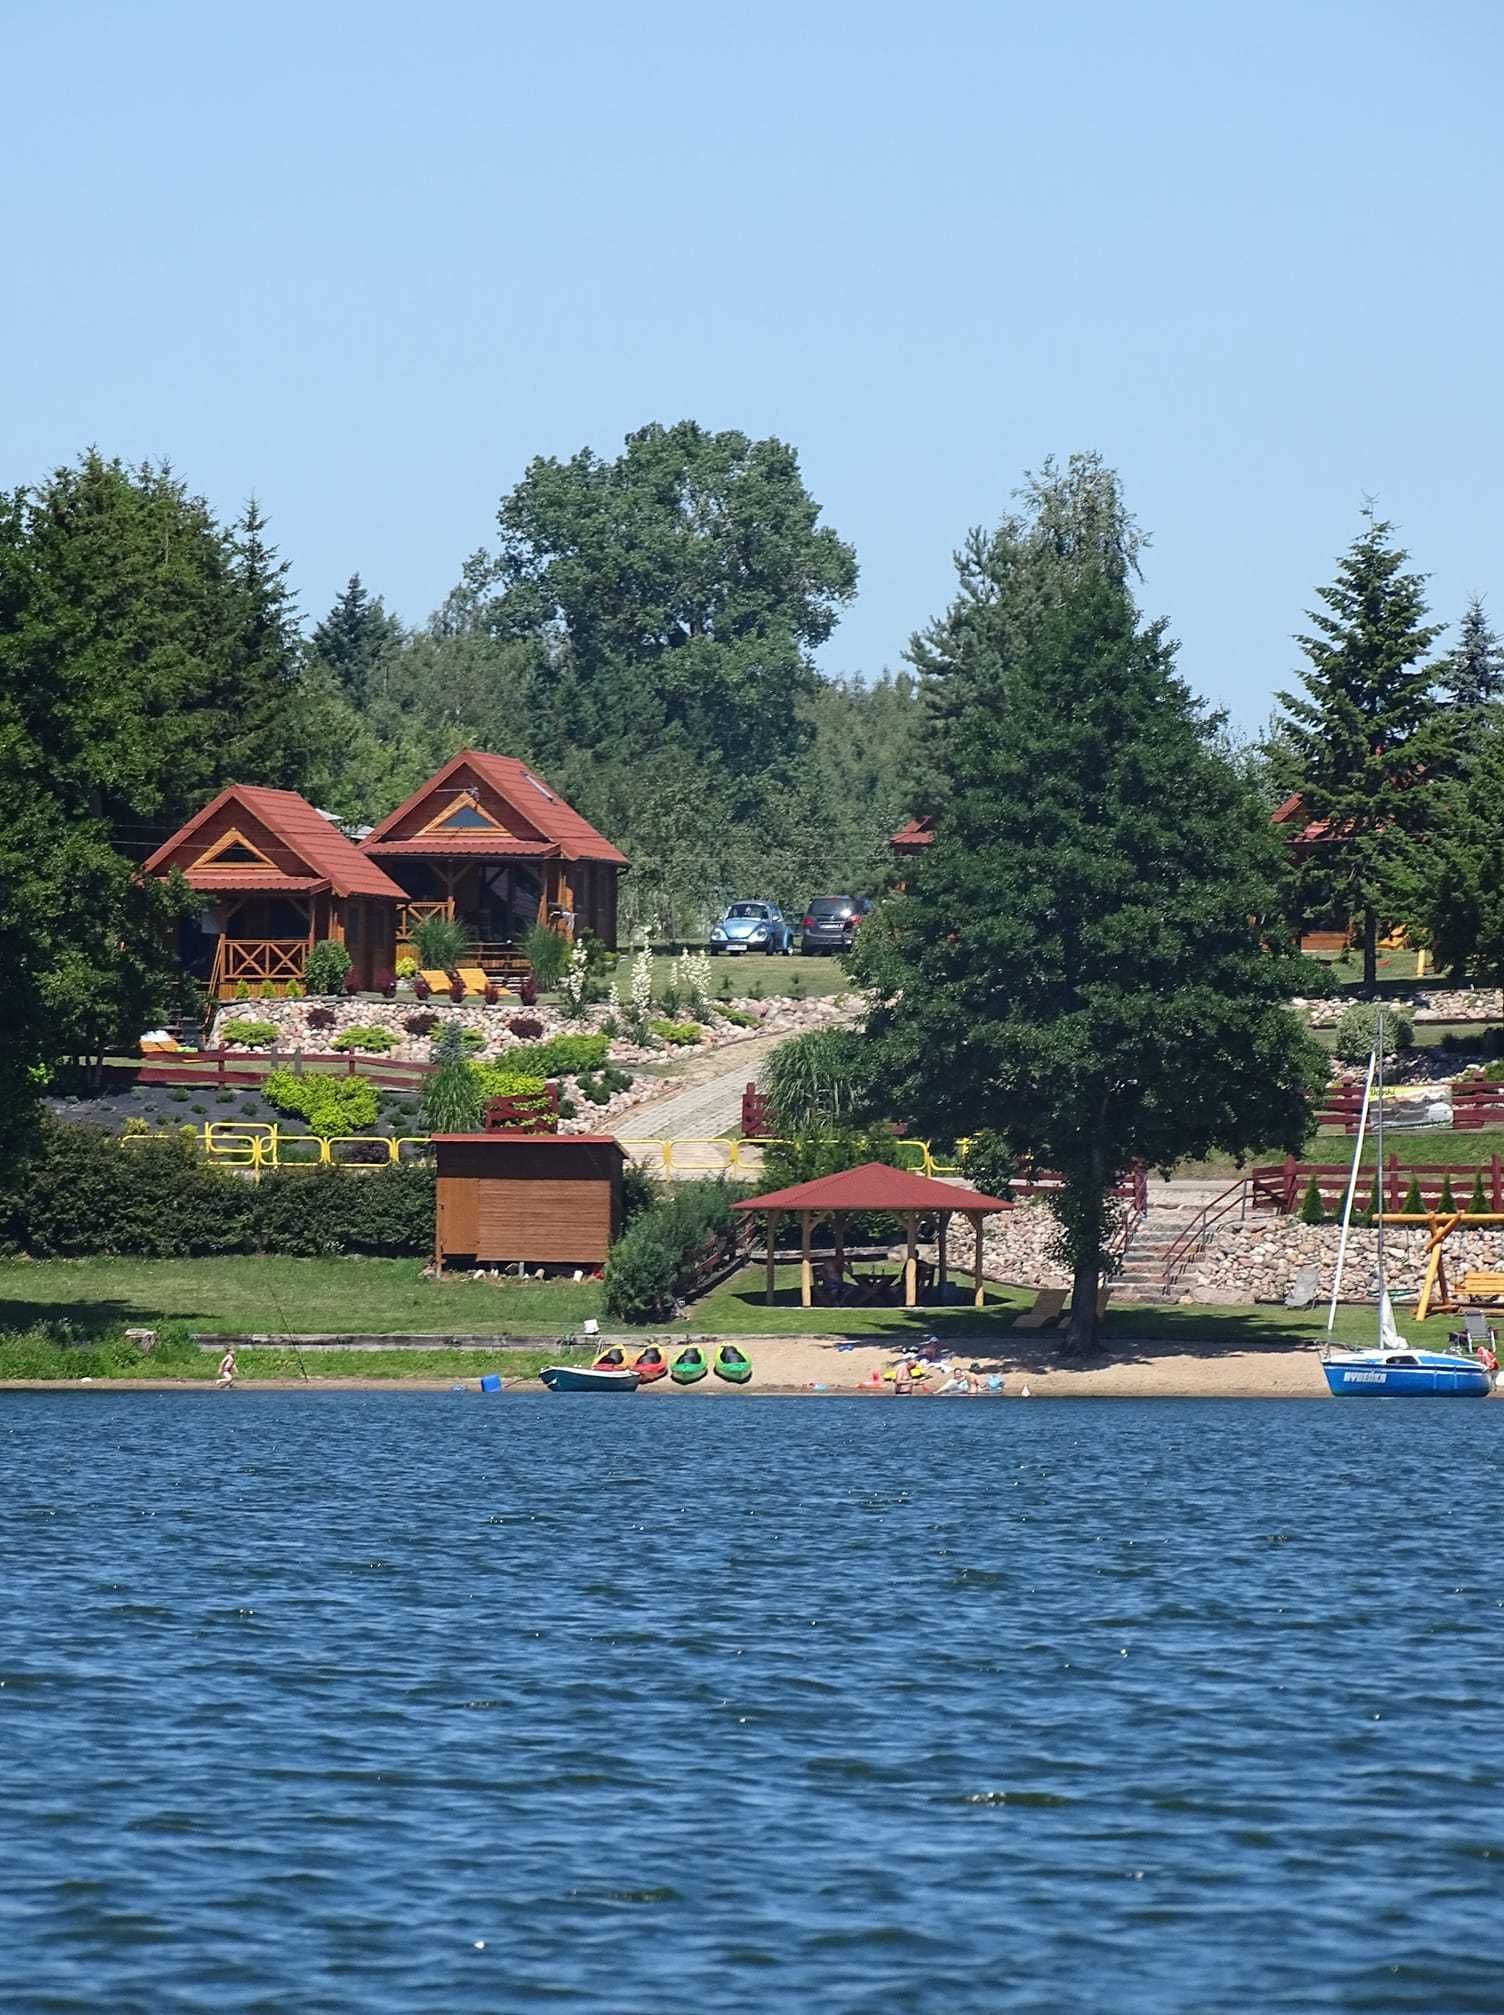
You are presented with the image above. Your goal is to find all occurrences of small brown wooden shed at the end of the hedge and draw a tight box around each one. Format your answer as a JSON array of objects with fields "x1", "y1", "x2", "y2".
[{"x1": 433, "y1": 1132, "x2": 627, "y2": 1267}]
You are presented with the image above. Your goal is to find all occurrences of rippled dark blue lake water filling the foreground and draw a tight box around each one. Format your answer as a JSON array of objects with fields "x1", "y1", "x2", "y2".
[{"x1": 0, "y1": 1392, "x2": 1504, "y2": 2015}]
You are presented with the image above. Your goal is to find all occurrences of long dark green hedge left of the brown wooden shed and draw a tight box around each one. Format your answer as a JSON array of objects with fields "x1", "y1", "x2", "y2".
[{"x1": 0, "y1": 1124, "x2": 433, "y2": 1259}]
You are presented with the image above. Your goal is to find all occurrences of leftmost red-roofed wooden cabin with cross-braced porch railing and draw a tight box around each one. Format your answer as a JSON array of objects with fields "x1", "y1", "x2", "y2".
[{"x1": 141, "y1": 784, "x2": 405, "y2": 999}]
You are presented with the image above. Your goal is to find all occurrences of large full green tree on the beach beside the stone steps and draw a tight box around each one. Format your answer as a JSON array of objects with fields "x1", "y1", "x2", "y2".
[{"x1": 857, "y1": 457, "x2": 1327, "y2": 1350}]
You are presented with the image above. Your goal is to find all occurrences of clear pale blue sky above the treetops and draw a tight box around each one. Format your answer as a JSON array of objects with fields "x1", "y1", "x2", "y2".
[{"x1": 0, "y1": 0, "x2": 1504, "y2": 723}]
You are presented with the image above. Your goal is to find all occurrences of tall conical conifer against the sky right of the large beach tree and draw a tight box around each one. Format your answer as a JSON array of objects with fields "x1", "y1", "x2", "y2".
[{"x1": 1278, "y1": 508, "x2": 1446, "y2": 989}]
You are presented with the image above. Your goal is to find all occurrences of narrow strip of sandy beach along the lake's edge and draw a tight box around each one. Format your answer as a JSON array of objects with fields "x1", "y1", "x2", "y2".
[{"x1": 0, "y1": 1336, "x2": 1362, "y2": 1400}]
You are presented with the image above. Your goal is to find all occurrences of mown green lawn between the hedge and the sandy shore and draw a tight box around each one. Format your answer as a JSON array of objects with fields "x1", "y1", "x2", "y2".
[{"x1": 0, "y1": 1257, "x2": 1448, "y2": 1378}]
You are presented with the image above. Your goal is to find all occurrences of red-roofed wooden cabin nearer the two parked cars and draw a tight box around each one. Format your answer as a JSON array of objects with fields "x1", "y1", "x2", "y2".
[{"x1": 361, "y1": 750, "x2": 627, "y2": 977}]
